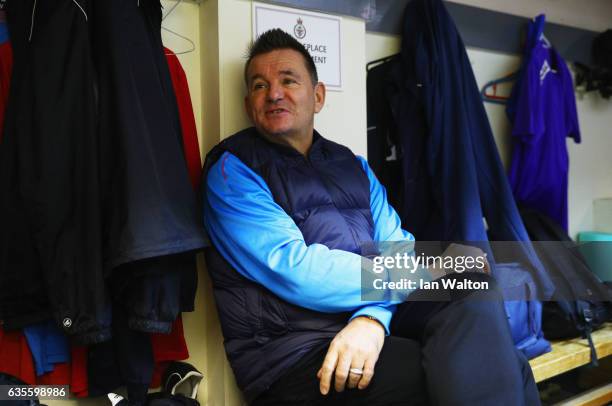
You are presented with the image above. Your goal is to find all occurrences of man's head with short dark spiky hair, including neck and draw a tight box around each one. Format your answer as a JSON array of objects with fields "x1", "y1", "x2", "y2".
[{"x1": 244, "y1": 29, "x2": 325, "y2": 152}]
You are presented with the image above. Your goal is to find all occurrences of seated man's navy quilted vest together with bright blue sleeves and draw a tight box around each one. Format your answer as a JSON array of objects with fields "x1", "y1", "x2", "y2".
[{"x1": 203, "y1": 128, "x2": 413, "y2": 400}]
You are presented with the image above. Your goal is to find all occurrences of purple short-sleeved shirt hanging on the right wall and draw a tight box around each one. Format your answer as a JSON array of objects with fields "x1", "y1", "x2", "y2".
[{"x1": 509, "y1": 41, "x2": 580, "y2": 230}]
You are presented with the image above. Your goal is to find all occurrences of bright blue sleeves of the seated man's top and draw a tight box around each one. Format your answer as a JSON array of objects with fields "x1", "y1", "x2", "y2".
[{"x1": 204, "y1": 152, "x2": 414, "y2": 334}]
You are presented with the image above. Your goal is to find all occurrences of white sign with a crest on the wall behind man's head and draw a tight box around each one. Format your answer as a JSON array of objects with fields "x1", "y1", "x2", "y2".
[{"x1": 253, "y1": 2, "x2": 342, "y2": 90}]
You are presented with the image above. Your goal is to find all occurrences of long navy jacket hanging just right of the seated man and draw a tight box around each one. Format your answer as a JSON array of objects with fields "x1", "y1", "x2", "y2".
[{"x1": 368, "y1": 0, "x2": 553, "y2": 297}]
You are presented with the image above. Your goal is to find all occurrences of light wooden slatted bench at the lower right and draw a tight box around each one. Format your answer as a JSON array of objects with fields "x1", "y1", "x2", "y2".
[{"x1": 529, "y1": 323, "x2": 612, "y2": 405}]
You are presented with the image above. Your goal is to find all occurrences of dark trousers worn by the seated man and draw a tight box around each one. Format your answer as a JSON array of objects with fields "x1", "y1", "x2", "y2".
[{"x1": 253, "y1": 274, "x2": 540, "y2": 406}]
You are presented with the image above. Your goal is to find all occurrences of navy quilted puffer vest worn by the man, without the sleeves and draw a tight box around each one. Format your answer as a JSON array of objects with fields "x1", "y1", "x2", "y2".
[{"x1": 203, "y1": 128, "x2": 374, "y2": 401}]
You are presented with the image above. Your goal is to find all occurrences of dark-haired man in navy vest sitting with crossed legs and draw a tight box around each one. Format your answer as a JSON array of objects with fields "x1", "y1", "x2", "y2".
[{"x1": 204, "y1": 30, "x2": 538, "y2": 405}]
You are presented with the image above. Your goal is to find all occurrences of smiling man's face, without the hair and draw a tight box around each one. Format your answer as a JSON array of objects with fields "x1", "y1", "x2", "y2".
[{"x1": 244, "y1": 49, "x2": 325, "y2": 143}]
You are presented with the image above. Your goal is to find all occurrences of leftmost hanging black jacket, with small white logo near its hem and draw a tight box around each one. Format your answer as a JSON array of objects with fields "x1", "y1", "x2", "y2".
[{"x1": 0, "y1": 0, "x2": 110, "y2": 338}]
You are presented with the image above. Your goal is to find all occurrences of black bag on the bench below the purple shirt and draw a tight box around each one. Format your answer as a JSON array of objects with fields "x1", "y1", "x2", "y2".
[{"x1": 521, "y1": 209, "x2": 612, "y2": 365}]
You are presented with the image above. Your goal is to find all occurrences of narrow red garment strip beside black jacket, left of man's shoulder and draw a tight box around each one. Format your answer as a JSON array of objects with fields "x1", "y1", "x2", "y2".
[{"x1": 164, "y1": 48, "x2": 202, "y2": 190}]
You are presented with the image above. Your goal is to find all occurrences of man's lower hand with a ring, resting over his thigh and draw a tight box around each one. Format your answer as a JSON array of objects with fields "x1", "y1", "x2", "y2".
[{"x1": 317, "y1": 317, "x2": 385, "y2": 395}]
